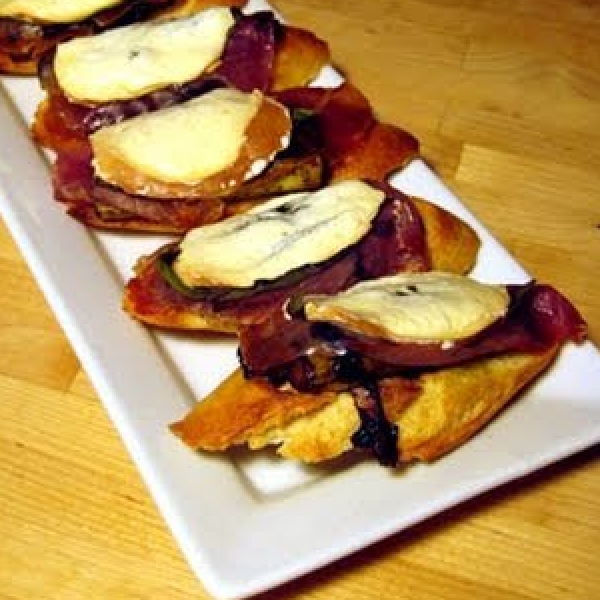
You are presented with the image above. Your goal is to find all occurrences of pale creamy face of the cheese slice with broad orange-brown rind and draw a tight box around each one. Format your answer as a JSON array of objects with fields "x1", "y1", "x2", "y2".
[{"x1": 90, "y1": 89, "x2": 263, "y2": 185}]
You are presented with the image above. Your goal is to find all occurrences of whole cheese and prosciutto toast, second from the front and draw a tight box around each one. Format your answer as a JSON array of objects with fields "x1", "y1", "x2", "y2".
[{"x1": 123, "y1": 180, "x2": 479, "y2": 333}]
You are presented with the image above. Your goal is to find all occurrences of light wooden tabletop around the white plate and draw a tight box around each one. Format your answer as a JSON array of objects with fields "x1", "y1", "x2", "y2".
[{"x1": 0, "y1": 0, "x2": 600, "y2": 600}]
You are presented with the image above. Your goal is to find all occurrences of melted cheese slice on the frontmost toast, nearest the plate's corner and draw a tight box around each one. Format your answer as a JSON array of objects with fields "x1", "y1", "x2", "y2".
[{"x1": 304, "y1": 271, "x2": 509, "y2": 342}]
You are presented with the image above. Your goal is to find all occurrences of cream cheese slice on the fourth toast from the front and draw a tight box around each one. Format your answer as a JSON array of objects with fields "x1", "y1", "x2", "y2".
[{"x1": 54, "y1": 8, "x2": 234, "y2": 102}]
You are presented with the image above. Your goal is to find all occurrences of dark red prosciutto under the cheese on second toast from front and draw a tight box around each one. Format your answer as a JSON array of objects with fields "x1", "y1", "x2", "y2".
[{"x1": 124, "y1": 188, "x2": 430, "y2": 327}]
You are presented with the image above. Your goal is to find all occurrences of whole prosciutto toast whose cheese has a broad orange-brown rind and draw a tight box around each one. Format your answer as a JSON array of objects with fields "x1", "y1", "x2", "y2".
[{"x1": 53, "y1": 84, "x2": 418, "y2": 234}]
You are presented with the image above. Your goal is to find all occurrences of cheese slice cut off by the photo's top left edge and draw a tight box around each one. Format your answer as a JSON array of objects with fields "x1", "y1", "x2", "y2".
[{"x1": 0, "y1": 0, "x2": 123, "y2": 23}]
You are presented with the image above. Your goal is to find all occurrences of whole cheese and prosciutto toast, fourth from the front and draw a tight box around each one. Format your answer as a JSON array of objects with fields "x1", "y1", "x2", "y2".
[{"x1": 33, "y1": 2, "x2": 329, "y2": 151}]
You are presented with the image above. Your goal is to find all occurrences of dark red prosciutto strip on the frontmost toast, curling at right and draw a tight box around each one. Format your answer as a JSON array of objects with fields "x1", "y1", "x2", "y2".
[{"x1": 240, "y1": 283, "x2": 587, "y2": 391}]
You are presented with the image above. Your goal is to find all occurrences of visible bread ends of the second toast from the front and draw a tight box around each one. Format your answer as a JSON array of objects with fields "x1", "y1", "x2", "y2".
[{"x1": 123, "y1": 199, "x2": 480, "y2": 333}]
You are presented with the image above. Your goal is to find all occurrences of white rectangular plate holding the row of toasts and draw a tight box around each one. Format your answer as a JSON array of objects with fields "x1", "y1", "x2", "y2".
[{"x1": 0, "y1": 3, "x2": 600, "y2": 598}]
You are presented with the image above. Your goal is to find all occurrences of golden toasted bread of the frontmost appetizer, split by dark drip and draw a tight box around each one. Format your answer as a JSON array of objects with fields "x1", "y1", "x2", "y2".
[{"x1": 171, "y1": 347, "x2": 557, "y2": 463}]
